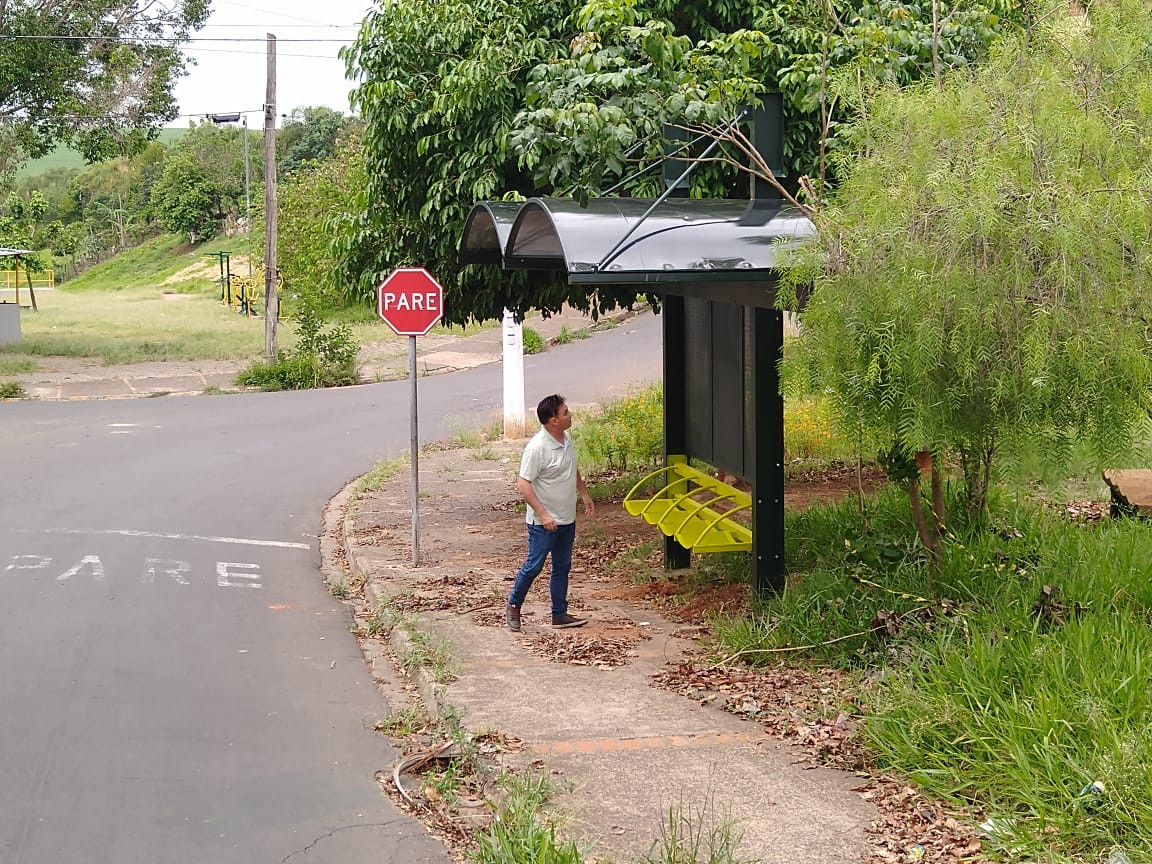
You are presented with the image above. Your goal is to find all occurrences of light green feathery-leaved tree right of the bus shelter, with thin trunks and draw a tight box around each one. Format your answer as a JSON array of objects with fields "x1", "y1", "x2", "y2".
[{"x1": 789, "y1": 0, "x2": 1152, "y2": 556}]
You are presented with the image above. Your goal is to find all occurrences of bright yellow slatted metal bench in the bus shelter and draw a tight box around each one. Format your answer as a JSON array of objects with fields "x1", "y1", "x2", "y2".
[{"x1": 624, "y1": 456, "x2": 752, "y2": 552}]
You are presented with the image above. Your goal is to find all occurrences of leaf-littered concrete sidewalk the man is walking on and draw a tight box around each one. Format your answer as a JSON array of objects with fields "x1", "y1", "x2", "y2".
[{"x1": 333, "y1": 442, "x2": 874, "y2": 864}]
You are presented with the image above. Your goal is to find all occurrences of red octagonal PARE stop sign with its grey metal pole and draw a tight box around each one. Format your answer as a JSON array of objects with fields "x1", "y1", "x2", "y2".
[{"x1": 376, "y1": 267, "x2": 444, "y2": 564}]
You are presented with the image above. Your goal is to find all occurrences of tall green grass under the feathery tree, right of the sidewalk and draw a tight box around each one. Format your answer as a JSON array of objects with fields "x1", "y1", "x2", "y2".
[{"x1": 718, "y1": 483, "x2": 1152, "y2": 862}]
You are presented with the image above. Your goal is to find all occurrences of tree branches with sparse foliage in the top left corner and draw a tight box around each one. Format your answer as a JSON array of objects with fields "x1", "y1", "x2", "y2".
[{"x1": 0, "y1": 0, "x2": 209, "y2": 176}]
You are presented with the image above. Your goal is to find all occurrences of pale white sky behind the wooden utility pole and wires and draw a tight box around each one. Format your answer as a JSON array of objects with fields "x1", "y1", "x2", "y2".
[{"x1": 169, "y1": 0, "x2": 372, "y2": 128}]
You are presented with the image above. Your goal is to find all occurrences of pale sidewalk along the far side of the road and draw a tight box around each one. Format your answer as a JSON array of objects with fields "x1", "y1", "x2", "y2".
[{"x1": 3, "y1": 309, "x2": 628, "y2": 401}]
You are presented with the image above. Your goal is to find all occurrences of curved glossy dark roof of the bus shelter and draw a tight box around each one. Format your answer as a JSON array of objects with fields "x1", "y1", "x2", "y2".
[{"x1": 460, "y1": 198, "x2": 816, "y2": 285}]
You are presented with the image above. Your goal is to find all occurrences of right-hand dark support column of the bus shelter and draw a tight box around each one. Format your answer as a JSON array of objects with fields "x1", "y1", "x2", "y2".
[{"x1": 751, "y1": 309, "x2": 785, "y2": 598}]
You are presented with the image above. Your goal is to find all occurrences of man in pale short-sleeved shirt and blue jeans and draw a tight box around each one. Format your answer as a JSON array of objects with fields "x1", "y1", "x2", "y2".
[{"x1": 505, "y1": 394, "x2": 596, "y2": 632}]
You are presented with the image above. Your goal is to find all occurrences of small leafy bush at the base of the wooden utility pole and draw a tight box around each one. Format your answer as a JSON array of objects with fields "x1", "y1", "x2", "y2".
[{"x1": 236, "y1": 301, "x2": 359, "y2": 391}]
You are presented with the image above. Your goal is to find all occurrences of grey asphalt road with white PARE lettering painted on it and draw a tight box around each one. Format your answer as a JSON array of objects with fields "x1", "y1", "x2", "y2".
[{"x1": 0, "y1": 316, "x2": 660, "y2": 864}]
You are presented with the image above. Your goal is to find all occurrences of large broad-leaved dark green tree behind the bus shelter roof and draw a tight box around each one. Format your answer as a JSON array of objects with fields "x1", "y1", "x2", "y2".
[{"x1": 336, "y1": 0, "x2": 1021, "y2": 321}]
